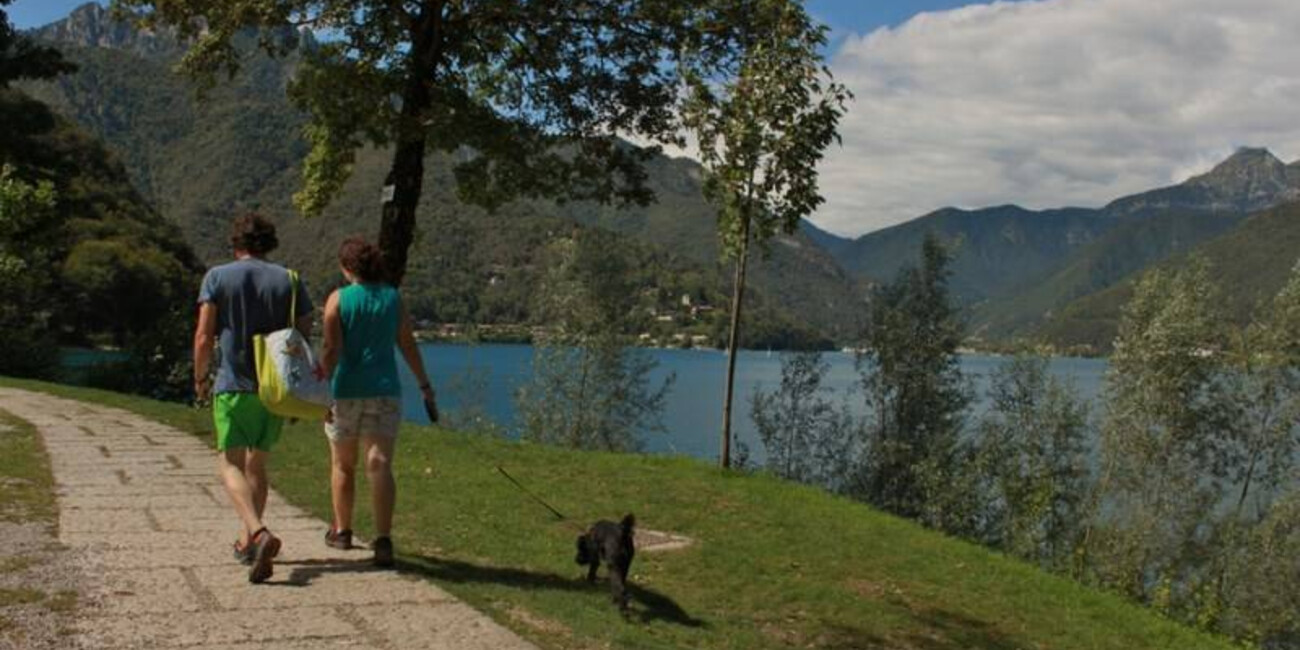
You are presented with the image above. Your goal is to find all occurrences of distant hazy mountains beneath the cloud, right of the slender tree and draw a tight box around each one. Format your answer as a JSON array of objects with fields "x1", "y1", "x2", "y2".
[{"x1": 805, "y1": 148, "x2": 1300, "y2": 351}]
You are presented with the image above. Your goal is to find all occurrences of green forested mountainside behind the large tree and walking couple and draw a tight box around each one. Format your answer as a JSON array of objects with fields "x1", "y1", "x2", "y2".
[{"x1": 29, "y1": 5, "x2": 862, "y2": 347}]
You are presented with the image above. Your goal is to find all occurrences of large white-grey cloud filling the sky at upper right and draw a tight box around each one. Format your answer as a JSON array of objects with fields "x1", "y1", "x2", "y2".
[{"x1": 813, "y1": 0, "x2": 1300, "y2": 235}]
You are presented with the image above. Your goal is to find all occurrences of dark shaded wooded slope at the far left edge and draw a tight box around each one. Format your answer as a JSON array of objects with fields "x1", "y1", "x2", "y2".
[{"x1": 0, "y1": 80, "x2": 202, "y2": 387}]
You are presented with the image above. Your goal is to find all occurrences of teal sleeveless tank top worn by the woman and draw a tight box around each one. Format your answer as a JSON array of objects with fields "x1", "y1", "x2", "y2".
[{"x1": 330, "y1": 285, "x2": 402, "y2": 399}]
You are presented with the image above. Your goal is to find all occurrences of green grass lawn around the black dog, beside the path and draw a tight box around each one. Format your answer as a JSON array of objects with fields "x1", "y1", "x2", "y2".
[{"x1": 0, "y1": 380, "x2": 1232, "y2": 650}]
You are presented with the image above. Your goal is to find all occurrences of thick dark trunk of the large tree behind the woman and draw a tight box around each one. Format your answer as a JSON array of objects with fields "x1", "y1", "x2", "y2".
[{"x1": 380, "y1": 0, "x2": 443, "y2": 286}]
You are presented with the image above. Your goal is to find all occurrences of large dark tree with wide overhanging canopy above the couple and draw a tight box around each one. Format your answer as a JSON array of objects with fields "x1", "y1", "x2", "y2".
[{"x1": 114, "y1": 0, "x2": 733, "y2": 281}]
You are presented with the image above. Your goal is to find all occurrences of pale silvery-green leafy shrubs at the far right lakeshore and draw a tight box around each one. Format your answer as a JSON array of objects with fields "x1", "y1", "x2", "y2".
[{"x1": 1089, "y1": 257, "x2": 1300, "y2": 645}]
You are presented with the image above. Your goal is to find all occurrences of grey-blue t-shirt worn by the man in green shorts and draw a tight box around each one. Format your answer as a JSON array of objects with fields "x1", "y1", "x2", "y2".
[{"x1": 199, "y1": 257, "x2": 313, "y2": 393}]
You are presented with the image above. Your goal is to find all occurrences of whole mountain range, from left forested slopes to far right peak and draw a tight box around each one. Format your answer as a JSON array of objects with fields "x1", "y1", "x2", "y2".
[{"x1": 25, "y1": 4, "x2": 1300, "y2": 351}]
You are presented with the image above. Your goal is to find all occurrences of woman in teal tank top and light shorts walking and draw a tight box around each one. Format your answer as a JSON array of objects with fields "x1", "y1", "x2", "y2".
[{"x1": 321, "y1": 237, "x2": 434, "y2": 567}]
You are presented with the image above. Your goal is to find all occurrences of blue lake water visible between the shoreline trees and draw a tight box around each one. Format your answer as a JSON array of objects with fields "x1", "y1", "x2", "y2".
[{"x1": 399, "y1": 343, "x2": 1106, "y2": 460}]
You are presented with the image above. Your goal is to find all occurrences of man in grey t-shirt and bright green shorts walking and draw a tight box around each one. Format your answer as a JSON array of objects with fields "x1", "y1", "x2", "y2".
[{"x1": 194, "y1": 215, "x2": 312, "y2": 584}]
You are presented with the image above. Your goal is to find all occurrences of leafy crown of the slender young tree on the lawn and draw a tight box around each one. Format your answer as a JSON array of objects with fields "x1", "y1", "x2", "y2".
[{"x1": 681, "y1": 0, "x2": 852, "y2": 257}]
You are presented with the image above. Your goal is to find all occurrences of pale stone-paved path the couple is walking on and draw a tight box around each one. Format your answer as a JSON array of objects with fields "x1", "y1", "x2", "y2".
[{"x1": 0, "y1": 389, "x2": 533, "y2": 650}]
